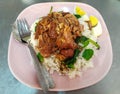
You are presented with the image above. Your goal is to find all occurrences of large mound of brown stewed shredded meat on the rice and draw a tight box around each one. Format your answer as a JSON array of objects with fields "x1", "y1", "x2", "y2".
[{"x1": 35, "y1": 12, "x2": 84, "y2": 60}]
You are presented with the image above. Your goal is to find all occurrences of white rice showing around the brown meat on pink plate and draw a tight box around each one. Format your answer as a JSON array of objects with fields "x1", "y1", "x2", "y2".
[{"x1": 30, "y1": 12, "x2": 100, "y2": 78}]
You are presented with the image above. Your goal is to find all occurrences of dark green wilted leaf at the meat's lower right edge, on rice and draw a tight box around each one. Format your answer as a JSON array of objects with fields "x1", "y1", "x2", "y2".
[{"x1": 64, "y1": 49, "x2": 80, "y2": 68}]
